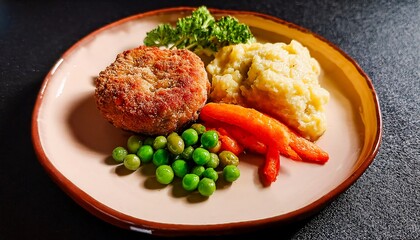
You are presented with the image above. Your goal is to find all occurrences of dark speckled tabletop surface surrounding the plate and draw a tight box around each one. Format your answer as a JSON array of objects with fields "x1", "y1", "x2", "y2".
[{"x1": 0, "y1": 0, "x2": 420, "y2": 239}]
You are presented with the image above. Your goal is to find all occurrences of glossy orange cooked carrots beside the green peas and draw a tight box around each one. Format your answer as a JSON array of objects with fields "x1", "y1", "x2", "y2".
[{"x1": 200, "y1": 103, "x2": 329, "y2": 185}]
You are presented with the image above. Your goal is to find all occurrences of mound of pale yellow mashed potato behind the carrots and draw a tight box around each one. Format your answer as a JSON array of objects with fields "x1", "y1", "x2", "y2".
[{"x1": 207, "y1": 40, "x2": 329, "y2": 141}]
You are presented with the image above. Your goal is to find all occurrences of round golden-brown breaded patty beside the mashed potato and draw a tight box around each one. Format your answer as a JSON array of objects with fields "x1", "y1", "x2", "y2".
[{"x1": 95, "y1": 46, "x2": 210, "y2": 135}]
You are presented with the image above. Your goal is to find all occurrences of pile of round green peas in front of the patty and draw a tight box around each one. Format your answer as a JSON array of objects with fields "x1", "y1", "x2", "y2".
[{"x1": 112, "y1": 123, "x2": 240, "y2": 197}]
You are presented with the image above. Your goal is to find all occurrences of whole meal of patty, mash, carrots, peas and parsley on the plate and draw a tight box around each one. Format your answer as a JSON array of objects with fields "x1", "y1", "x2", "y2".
[{"x1": 100, "y1": 6, "x2": 329, "y2": 189}]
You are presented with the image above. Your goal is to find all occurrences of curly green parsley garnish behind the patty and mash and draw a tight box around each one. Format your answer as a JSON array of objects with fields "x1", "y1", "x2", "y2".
[{"x1": 143, "y1": 6, "x2": 255, "y2": 56}]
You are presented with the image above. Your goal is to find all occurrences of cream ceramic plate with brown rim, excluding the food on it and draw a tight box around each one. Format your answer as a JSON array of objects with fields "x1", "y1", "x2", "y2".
[{"x1": 32, "y1": 7, "x2": 382, "y2": 236}]
